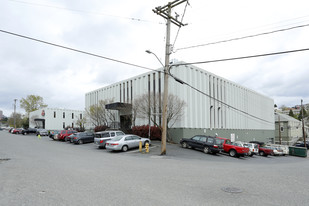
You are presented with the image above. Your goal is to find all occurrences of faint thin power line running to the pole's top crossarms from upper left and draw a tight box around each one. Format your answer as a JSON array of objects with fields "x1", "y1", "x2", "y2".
[{"x1": 9, "y1": 0, "x2": 163, "y2": 24}]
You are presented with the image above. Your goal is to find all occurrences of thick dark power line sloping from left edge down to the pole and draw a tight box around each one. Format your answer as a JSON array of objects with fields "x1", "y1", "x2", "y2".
[{"x1": 0, "y1": 30, "x2": 157, "y2": 71}]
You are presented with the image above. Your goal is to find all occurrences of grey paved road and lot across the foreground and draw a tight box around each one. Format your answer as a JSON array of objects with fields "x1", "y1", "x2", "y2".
[{"x1": 0, "y1": 131, "x2": 309, "y2": 206}]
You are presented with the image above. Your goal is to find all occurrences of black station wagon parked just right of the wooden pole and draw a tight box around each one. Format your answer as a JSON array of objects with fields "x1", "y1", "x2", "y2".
[{"x1": 180, "y1": 135, "x2": 222, "y2": 154}]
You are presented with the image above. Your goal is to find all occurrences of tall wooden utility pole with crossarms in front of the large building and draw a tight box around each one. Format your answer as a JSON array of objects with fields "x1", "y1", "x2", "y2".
[{"x1": 152, "y1": 0, "x2": 187, "y2": 155}]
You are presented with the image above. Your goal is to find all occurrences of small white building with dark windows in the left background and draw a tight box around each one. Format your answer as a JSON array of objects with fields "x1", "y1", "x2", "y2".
[{"x1": 29, "y1": 108, "x2": 84, "y2": 130}]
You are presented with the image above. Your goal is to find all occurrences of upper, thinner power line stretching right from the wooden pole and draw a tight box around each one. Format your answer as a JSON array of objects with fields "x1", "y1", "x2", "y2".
[{"x1": 175, "y1": 24, "x2": 309, "y2": 52}]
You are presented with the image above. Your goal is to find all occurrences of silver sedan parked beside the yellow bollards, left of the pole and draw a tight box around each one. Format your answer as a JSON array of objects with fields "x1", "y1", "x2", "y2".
[{"x1": 106, "y1": 134, "x2": 151, "y2": 152}]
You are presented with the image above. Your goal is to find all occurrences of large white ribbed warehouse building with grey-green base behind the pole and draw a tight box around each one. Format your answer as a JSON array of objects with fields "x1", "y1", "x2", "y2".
[{"x1": 85, "y1": 62, "x2": 275, "y2": 142}]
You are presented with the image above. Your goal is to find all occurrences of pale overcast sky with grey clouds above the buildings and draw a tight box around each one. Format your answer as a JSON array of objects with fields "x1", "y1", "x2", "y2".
[{"x1": 0, "y1": 0, "x2": 309, "y2": 116}]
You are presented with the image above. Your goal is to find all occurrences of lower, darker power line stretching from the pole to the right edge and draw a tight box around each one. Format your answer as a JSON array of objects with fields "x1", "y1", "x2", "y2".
[{"x1": 173, "y1": 48, "x2": 309, "y2": 66}]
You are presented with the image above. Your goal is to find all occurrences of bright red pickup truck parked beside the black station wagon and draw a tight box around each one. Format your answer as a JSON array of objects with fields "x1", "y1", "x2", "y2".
[{"x1": 217, "y1": 137, "x2": 249, "y2": 157}]
